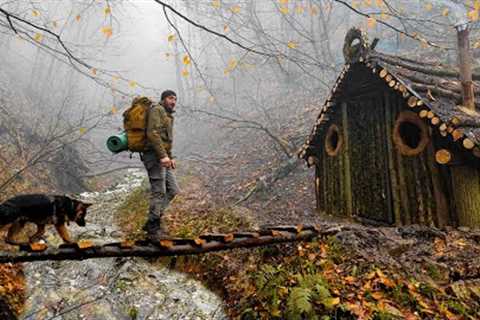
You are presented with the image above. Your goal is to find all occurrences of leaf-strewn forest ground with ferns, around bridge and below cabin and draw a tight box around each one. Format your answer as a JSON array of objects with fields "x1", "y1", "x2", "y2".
[{"x1": 117, "y1": 162, "x2": 480, "y2": 319}]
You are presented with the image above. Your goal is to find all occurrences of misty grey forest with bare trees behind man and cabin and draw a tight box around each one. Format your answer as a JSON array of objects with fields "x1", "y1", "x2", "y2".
[{"x1": 0, "y1": 0, "x2": 478, "y2": 219}]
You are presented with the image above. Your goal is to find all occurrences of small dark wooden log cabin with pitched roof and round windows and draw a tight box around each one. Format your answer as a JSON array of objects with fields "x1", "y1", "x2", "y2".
[{"x1": 299, "y1": 28, "x2": 480, "y2": 227}]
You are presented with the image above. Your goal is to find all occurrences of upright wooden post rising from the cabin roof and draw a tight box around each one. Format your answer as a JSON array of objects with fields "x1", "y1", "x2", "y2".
[{"x1": 456, "y1": 24, "x2": 475, "y2": 110}]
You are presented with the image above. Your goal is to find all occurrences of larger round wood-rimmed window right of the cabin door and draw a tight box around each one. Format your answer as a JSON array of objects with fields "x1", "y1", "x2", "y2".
[{"x1": 393, "y1": 111, "x2": 429, "y2": 156}]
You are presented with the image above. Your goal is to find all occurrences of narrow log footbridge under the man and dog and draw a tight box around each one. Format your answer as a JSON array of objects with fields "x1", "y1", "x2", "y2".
[{"x1": 0, "y1": 225, "x2": 346, "y2": 263}]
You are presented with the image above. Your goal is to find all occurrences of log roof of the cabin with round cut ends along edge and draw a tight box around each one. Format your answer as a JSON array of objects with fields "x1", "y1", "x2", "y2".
[{"x1": 299, "y1": 28, "x2": 480, "y2": 159}]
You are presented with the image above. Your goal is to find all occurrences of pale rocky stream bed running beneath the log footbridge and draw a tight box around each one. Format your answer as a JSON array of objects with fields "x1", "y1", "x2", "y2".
[{"x1": 20, "y1": 170, "x2": 227, "y2": 320}]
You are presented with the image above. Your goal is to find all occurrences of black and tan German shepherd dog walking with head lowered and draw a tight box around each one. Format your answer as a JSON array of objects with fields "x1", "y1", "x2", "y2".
[{"x1": 0, "y1": 194, "x2": 92, "y2": 245}]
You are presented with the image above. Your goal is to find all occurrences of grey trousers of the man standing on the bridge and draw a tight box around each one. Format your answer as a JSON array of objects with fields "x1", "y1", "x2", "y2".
[{"x1": 142, "y1": 151, "x2": 179, "y2": 234}]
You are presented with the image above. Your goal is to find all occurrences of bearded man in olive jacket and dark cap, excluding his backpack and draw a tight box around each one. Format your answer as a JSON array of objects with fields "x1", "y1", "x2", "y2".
[{"x1": 142, "y1": 90, "x2": 178, "y2": 240}]
